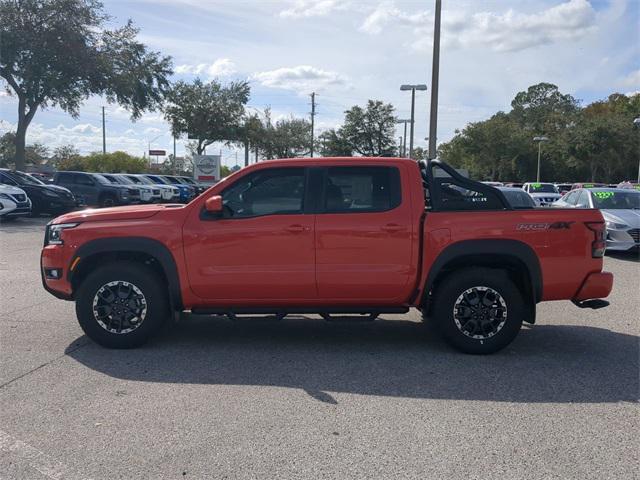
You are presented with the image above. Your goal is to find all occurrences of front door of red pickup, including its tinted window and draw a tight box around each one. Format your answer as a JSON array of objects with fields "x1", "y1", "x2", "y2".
[{"x1": 183, "y1": 168, "x2": 317, "y2": 306}]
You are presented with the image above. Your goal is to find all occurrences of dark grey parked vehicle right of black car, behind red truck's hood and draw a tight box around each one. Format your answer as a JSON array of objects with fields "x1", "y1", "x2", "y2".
[{"x1": 53, "y1": 171, "x2": 140, "y2": 207}]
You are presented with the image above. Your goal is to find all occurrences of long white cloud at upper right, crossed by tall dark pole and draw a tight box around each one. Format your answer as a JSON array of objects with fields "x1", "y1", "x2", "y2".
[{"x1": 360, "y1": 0, "x2": 596, "y2": 51}]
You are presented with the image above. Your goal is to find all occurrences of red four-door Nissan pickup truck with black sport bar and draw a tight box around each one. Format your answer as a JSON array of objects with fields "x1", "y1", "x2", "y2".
[{"x1": 41, "y1": 158, "x2": 613, "y2": 353}]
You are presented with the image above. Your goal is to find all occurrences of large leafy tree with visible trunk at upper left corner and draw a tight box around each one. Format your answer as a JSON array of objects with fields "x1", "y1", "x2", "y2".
[{"x1": 0, "y1": 0, "x2": 172, "y2": 169}]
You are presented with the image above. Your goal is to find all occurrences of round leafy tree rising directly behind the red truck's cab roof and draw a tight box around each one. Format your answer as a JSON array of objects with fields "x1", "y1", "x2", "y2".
[{"x1": 340, "y1": 100, "x2": 396, "y2": 157}]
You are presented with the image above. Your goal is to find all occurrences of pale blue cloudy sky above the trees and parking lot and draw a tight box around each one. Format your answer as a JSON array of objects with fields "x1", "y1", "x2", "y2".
[{"x1": 0, "y1": 0, "x2": 640, "y2": 166}]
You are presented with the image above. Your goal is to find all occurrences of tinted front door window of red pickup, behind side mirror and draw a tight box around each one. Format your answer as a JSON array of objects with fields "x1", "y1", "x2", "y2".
[{"x1": 222, "y1": 168, "x2": 305, "y2": 218}]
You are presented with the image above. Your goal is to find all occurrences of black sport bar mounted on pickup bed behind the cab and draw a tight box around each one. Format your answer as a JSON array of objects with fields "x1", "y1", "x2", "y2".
[{"x1": 433, "y1": 167, "x2": 505, "y2": 211}]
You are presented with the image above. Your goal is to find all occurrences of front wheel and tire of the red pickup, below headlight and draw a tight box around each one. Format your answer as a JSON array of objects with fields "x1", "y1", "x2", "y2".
[{"x1": 76, "y1": 262, "x2": 170, "y2": 348}]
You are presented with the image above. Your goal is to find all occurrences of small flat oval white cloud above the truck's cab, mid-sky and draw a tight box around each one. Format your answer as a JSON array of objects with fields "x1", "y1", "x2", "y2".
[{"x1": 251, "y1": 65, "x2": 348, "y2": 93}]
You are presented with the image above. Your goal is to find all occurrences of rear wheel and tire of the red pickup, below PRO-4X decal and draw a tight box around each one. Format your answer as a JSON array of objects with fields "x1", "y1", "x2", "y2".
[{"x1": 432, "y1": 267, "x2": 525, "y2": 355}]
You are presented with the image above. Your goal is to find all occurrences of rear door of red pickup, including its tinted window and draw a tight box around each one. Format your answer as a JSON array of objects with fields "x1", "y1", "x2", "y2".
[{"x1": 316, "y1": 167, "x2": 415, "y2": 305}]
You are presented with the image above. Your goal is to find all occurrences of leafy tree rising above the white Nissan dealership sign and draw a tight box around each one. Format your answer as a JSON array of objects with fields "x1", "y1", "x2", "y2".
[{"x1": 164, "y1": 79, "x2": 250, "y2": 155}]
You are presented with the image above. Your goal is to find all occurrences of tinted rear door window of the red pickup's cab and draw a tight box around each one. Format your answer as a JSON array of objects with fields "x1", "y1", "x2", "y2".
[{"x1": 324, "y1": 167, "x2": 401, "y2": 213}]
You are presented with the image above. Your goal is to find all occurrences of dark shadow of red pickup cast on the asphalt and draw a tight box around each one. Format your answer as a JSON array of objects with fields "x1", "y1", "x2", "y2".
[{"x1": 67, "y1": 316, "x2": 639, "y2": 404}]
